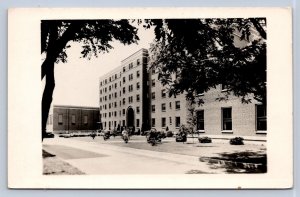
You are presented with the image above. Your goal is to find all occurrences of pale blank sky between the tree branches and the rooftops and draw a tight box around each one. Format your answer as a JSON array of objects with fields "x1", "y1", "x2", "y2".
[{"x1": 52, "y1": 24, "x2": 154, "y2": 107}]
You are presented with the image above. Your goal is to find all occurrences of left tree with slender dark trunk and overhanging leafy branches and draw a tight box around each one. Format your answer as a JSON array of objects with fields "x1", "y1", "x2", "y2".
[{"x1": 41, "y1": 20, "x2": 139, "y2": 140}]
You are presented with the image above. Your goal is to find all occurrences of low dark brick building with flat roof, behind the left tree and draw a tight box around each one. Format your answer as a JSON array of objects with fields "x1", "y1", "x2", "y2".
[{"x1": 46, "y1": 105, "x2": 99, "y2": 133}]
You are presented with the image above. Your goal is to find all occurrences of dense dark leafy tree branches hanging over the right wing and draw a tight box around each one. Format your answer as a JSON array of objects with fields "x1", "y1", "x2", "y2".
[{"x1": 145, "y1": 18, "x2": 266, "y2": 104}]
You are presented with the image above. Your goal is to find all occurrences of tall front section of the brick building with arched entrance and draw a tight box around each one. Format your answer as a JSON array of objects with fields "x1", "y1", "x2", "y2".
[{"x1": 99, "y1": 49, "x2": 150, "y2": 130}]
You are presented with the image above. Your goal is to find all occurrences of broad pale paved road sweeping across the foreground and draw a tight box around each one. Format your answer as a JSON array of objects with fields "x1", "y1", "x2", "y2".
[{"x1": 43, "y1": 137, "x2": 224, "y2": 174}]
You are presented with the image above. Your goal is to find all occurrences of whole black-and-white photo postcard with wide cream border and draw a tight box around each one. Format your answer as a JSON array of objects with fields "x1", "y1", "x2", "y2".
[{"x1": 8, "y1": 7, "x2": 293, "y2": 189}]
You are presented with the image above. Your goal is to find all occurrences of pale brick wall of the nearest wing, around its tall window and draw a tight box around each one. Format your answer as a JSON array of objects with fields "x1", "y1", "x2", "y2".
[{"x1": 195, "y1": 85, "x2": 267, "y2": 136}]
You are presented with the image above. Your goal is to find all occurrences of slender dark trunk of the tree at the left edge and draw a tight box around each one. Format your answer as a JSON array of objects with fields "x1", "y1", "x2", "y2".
[{"x1": 42, "y1": 58, "x2": 55, "y2": 140}]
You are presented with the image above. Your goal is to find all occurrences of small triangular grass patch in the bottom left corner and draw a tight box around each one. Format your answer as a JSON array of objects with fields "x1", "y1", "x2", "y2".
[{"x1": 43, "y1": 150, "x2": 84, "y2": 175}]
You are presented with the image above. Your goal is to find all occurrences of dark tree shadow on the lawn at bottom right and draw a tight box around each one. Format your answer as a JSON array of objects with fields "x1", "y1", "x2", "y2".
[{"x1": 199, "y1": 151, "x2": 267, "y2": 173}]
